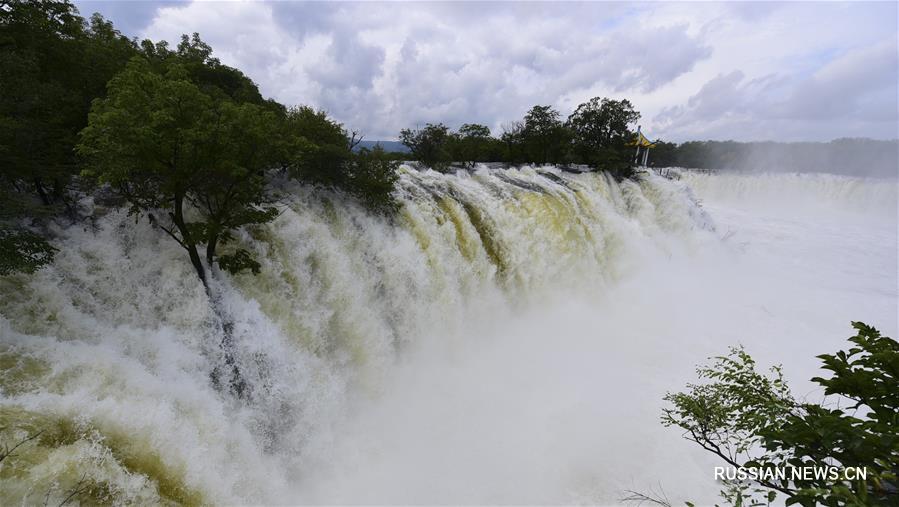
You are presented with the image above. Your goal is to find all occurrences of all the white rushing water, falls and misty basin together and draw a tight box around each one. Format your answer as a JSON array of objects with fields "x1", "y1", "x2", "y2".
[{"x1": 0, "y1": 167, "x2": 897, "y2": 504}]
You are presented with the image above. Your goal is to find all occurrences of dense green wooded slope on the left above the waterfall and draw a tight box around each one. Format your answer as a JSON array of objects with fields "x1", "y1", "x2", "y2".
[{"x1": 0, "y1": 0, "x2": 398, "y2": 284}]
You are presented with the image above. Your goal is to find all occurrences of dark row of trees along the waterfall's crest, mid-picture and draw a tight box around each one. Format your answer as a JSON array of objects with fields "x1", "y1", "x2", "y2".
[{"x1": 399, "y1": 97, "x2": 640, "y2": 178}]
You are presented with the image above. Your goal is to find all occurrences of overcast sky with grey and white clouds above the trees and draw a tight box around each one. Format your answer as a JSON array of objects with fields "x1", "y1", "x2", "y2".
[{"x1": 76, "y1": 1, "x2": 899, "y2": 142}]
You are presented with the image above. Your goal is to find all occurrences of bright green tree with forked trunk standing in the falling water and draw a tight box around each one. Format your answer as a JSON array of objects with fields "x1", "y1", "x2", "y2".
[{"x1": 78, "y1": 57, "x2": 278, "y2": 285}]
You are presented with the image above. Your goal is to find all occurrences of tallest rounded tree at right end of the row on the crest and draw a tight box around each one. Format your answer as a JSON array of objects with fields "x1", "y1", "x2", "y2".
[{"x1": 566, "y1": 97, "x2": 640, "y2": 177}]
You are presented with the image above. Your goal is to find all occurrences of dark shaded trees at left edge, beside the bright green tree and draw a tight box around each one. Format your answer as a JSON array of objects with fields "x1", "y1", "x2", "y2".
[{"x1": 0, "y1": 0, "x2": 136, "y2": 274}]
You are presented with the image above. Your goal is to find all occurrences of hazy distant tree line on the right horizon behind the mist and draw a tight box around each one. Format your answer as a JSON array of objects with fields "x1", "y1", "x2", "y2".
[{"x1": 649, "y1": 139, "x2": 899, "y2": 177}]
